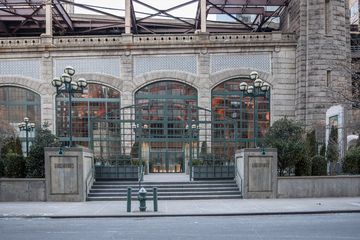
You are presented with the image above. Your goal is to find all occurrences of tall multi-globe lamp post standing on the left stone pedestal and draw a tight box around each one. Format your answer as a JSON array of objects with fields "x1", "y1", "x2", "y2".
[{"x1": 52, "y1": 66, "x2": 87, "y2": 147}]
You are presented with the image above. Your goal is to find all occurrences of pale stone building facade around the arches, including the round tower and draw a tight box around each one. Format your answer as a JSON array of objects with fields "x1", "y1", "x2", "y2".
[{"x1": 0, "y1": 0, "x2": 351, "y2": 172}]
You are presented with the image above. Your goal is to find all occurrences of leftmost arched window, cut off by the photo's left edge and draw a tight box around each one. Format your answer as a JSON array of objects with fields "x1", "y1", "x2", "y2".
[{"x1": 0, "y1": 86, "x2": 41, "y2": 153}]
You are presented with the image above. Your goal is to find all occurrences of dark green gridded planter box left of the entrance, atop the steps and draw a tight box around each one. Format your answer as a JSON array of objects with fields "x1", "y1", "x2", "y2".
[{"x1": 95, "y1": 166, "x2": 140, "y2": 181}]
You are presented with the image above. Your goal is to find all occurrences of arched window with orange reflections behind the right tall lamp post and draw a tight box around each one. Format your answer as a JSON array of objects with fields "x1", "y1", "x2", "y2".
[{"x1": 211, "y1": 77, "x2": 270, "y2": 148}]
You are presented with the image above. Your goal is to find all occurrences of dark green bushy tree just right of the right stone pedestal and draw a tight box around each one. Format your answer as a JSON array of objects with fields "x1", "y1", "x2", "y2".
[{"x1": 265, "y1": 117, "x2": 305, "y2": 176}]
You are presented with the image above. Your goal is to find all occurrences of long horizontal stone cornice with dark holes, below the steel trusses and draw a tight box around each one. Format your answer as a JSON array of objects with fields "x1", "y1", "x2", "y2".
[{"x1": 0, "y1": 32, "x2": 297, "y2": 52}]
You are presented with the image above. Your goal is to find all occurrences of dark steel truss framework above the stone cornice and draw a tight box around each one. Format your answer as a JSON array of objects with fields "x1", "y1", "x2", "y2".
[{"x1": 0, "y1": 0, "x2": 291, "y2": 37}]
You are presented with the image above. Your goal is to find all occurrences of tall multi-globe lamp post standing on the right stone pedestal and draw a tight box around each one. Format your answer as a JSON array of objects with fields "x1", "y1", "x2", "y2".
[{"x1": 240, "y1": 71, "x2": 270, "y2": 147}]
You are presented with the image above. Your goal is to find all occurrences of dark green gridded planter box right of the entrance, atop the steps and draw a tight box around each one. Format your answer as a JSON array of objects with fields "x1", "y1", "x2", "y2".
[{"x1": 192, "y1": 166, "x2": 235, "y2": 180}]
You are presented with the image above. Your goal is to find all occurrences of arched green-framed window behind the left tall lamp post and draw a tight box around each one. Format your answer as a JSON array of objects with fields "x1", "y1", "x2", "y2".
[{"x1": 56, "y1": 83, "x2": 120, "y2": 147}]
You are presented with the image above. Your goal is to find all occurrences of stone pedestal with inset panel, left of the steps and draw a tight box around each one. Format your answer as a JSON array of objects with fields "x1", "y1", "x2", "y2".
[{"x1": 45, "y1": 148, "x2": 94, "y2": 202}]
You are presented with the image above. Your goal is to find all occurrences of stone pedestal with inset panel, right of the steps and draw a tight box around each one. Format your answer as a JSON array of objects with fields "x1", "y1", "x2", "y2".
[{"x1": 235, "y1": 148, "x2": 277, "y2": 198}]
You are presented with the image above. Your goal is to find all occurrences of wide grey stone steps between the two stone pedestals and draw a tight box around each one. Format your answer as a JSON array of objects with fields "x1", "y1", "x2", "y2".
[{"x1": 87, "y1": 180, "x2": 242, "y2": 201}]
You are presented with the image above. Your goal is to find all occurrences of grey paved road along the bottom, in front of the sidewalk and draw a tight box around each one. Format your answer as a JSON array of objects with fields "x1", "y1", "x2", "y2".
[{"x1": 0, "y1": 213, "x2": 360, "y2": 240}]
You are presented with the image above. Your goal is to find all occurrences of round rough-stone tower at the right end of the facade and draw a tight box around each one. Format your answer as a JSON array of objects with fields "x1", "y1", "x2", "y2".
[{"x1": 282, "y1": 0, "x2": 351, "y2": 133}]
